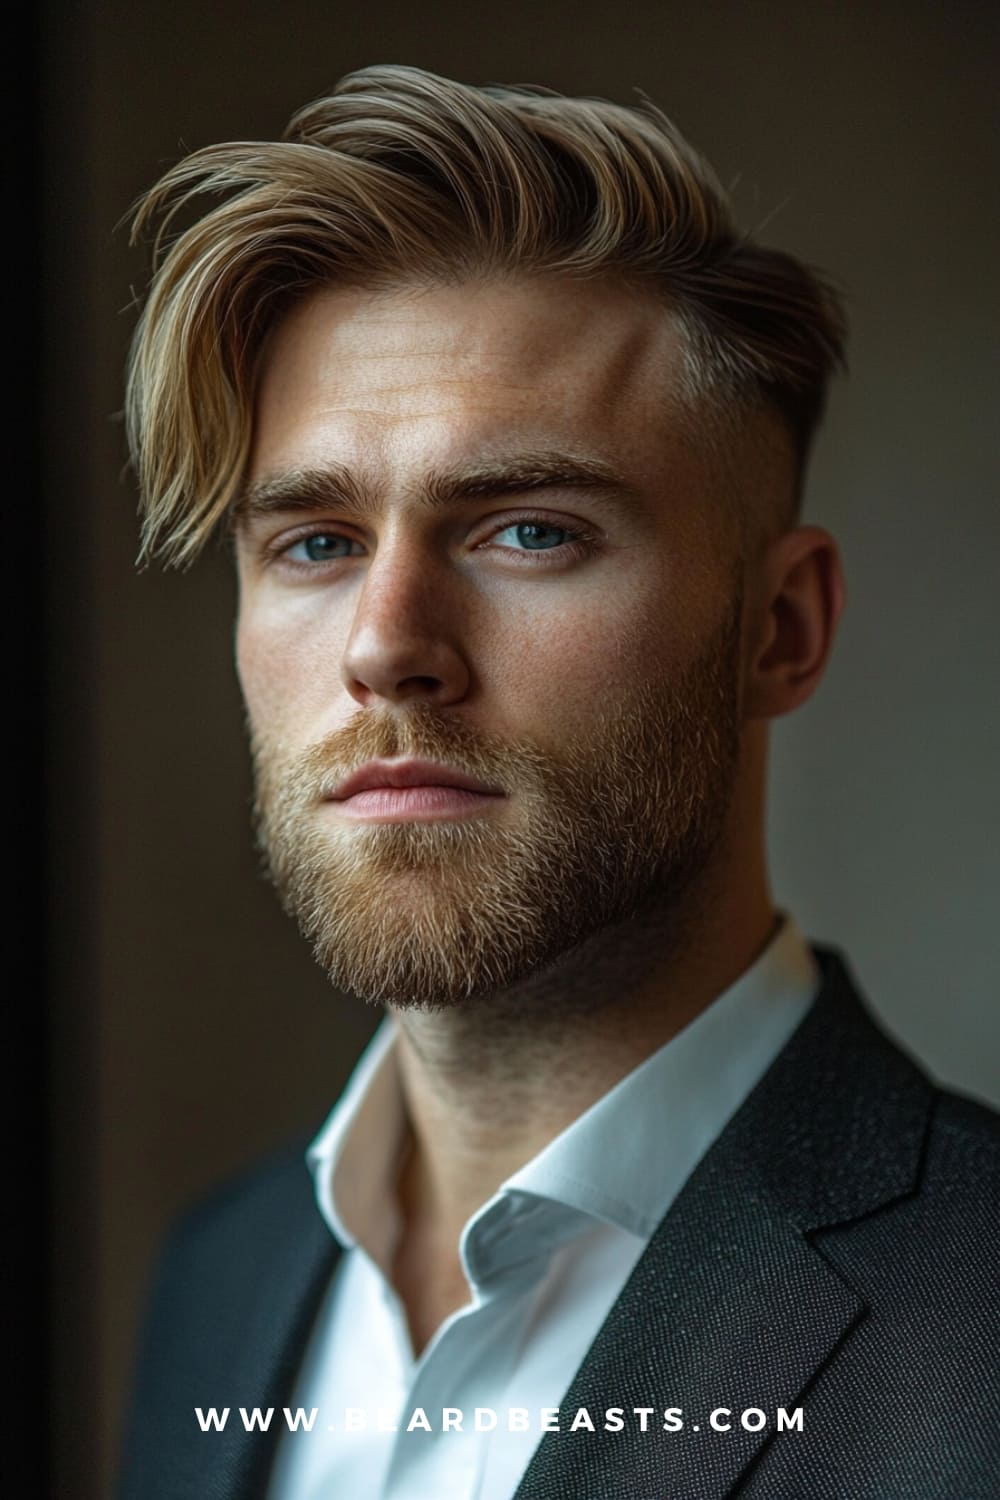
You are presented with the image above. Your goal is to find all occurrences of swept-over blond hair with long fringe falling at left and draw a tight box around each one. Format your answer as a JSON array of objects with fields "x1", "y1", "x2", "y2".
[{"x1": 126, "y1": 66, "x2": 844, "y2": 566}]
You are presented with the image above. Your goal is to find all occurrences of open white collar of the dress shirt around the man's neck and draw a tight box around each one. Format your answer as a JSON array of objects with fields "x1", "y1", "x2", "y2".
[{"x1": 307, "y1": 914, "x2": 819, "y2": 1268}]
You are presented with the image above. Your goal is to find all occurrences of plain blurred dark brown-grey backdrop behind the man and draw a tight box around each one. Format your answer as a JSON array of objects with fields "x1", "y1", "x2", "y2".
[{"x1": 41, "y1": 0, "x2": 1000, "y2": 1500}]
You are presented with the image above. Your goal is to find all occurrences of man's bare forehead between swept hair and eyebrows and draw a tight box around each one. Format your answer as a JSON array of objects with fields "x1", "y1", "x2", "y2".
[{"x1": 249, "y1": 279, "x2": 695, "y2": 480}]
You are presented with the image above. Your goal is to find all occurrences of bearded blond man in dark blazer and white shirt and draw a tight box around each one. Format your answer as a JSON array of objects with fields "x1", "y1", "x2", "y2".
[{"x1": 121, "y1": 68, "x2": 1000, "y2": 1500}]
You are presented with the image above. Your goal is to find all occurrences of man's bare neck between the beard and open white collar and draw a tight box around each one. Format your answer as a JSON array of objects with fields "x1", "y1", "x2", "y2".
[{"x1": 394, "y1": 828, "x2": 777, "y2": 1245}]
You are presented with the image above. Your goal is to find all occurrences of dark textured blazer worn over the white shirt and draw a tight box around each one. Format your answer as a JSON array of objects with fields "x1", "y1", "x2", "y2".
[{"x1": 120, "y1": 945, "x2": 1000, "y2": 1500}]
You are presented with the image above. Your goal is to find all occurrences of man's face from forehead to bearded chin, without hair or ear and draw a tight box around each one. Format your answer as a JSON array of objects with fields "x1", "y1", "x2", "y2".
[{"x1": 237, "y1": 279, "x2": 761, "y2": 1005}]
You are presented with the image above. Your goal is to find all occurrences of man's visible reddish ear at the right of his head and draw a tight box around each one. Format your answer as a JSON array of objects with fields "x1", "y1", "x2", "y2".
[{"x1": 744, "y1": 527, "x2": 847, "y2": 719}]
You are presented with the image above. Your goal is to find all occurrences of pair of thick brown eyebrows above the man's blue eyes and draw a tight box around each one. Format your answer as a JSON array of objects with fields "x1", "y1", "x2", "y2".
[{"x1": 231, "y1": 450, "x2": 637, "y2": 528}]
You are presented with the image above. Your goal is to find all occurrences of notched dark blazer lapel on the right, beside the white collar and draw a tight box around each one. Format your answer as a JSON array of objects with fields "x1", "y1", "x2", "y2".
[{"x1": 516, "y1": 948, "x2": 930, "y2": 1500}]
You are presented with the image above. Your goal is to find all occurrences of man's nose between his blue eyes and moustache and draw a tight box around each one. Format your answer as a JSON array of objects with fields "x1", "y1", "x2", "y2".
[{"x1": 342, "y1": 542, "x2": 471, "y2": 708}]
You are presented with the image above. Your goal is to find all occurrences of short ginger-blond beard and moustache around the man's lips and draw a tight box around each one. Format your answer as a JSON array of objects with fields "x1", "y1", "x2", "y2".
[{"x1": 252, "y1": 600, "x2": 741, "y2": 1008}]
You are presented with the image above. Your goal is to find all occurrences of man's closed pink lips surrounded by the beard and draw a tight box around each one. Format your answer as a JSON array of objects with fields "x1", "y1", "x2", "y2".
[{"x1": 327, "y1": 761, "x2": 505, "y2": 824}]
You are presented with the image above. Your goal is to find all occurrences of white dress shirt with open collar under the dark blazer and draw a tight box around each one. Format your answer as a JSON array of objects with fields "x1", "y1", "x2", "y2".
[{"x1": 268, "y1": 915, "x2": 819, "y2": 1500}]
